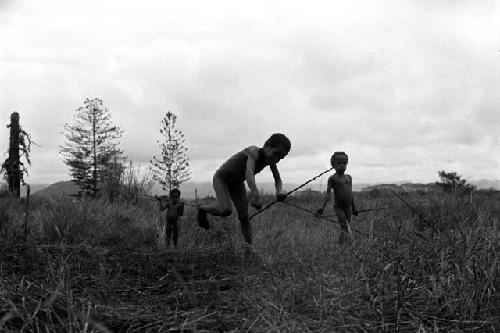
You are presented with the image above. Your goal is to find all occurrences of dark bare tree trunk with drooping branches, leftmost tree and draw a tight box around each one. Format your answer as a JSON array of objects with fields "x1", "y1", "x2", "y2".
[{"x1": 1, "y1": 112, "x2": 31, "y2": 198}]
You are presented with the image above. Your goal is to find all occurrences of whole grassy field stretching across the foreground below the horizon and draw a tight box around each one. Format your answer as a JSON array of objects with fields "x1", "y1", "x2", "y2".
[{"x1": 0, "y1": 190, "x2": 500, "y2": 332}]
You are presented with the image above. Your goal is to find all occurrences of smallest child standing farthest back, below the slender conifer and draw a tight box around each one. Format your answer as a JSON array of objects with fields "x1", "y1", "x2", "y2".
[{"x1": 157, "y1": 188, "x2": 184, "y2": 247}]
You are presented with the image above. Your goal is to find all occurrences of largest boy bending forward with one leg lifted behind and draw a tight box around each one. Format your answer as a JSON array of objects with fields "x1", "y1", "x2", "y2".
[{"x1": 198, "y1": 133, "x2": 291, "y2": 244}]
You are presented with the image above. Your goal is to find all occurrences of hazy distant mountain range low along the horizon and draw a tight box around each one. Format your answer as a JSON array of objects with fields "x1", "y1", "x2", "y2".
[{"x1": 28, "y1": 179, "x2": 500, "y2": 198}]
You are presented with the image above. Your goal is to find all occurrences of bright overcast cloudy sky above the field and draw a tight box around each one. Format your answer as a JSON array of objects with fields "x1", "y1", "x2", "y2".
[{"x1": 0, "y1": 0, "x2": 500, "y2": 183}]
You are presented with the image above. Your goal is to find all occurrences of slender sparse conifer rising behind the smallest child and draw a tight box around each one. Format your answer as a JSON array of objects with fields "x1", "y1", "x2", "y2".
[{"x1": 151, "y1": 112, "x2": 191, "y2": 191}]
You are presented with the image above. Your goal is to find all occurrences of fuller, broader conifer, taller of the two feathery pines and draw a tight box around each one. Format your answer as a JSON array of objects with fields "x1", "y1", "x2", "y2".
[{"x1": 60, "y1": 98, "x2": 124, "y2": 197}]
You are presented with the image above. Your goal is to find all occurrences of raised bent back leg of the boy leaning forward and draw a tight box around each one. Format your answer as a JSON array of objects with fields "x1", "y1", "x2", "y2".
[{"x1": 198, "y1": 172, "x2": 231, "y2": 229}]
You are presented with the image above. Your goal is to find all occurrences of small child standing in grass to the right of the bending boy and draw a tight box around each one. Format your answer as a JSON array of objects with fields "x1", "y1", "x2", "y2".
[{"x1": 317, "y1": 151, "x2": 358, "y2": 244}]
